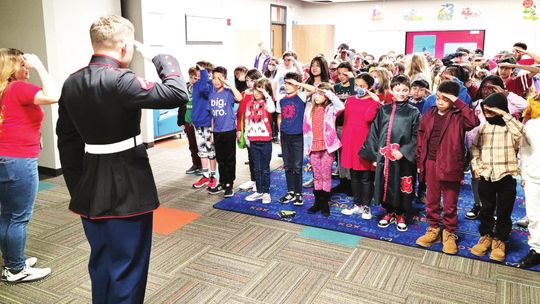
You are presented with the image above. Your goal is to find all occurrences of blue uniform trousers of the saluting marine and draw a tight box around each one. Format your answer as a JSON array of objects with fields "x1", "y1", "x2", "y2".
[{"x1": 81, "y1": 212, "x2": 154, "y2": 304}]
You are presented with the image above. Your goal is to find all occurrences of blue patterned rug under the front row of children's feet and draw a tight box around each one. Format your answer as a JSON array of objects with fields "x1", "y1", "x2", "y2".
[{"x1": 214, "y1": 168, "x2": 540, "y2": 271}]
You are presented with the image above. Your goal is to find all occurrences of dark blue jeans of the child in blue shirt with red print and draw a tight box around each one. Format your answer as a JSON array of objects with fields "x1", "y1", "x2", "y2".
[{"x1": 281, "y1": 132, "x2": 304, "y2": 193}]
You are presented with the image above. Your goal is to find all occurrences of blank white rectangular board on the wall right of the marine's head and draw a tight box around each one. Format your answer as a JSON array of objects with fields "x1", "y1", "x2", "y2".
[{"x1": 185, "y1": 15, "x2": 226, "y2": 44}]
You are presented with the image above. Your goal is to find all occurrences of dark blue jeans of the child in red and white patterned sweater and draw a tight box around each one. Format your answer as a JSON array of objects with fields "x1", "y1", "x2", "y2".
[{"x1": 249, "y1": 141, "x2": 272, "y2": 193}]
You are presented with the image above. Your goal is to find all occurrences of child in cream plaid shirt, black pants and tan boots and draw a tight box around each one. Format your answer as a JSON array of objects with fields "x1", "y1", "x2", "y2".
[{"x1": 470, "y1": 93, "x2": 524, "y2": 262}]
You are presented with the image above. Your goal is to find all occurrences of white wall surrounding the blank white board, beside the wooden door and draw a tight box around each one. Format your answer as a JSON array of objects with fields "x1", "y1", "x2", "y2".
[{"x1": 123, "y1": 0, "x2": 303, "y2": 77}]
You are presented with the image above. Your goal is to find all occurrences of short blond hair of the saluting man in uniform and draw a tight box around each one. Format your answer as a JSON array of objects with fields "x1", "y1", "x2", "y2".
[{"x1": 90, "y1": 15, "x2": 135, "y2": 48}]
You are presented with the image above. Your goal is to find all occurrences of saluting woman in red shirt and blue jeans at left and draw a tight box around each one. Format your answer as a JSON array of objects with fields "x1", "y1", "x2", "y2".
[{"x1": 0, "y1": 48, "x2": 59, "y2": 283}]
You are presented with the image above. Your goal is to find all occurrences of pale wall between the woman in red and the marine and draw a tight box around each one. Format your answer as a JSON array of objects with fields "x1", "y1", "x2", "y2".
[{"x1": 0, "y1": 0, "x2": 120, "y2": 169}]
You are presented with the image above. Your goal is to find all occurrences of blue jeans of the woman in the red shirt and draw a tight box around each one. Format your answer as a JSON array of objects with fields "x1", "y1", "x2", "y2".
[{"x1": 0, "y1": 156, "x2": 39, "y2": 271}]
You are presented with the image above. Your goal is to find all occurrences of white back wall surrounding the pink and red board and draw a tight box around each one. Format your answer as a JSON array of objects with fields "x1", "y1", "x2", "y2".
[{"x1": 297, "y1": 0, "x2": 540, "y2": 56}]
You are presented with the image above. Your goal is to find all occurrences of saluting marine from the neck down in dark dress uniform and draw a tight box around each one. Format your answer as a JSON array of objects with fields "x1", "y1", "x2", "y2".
[{"x1": 56, "y1": 54, "x2": 188, "y2": 303}]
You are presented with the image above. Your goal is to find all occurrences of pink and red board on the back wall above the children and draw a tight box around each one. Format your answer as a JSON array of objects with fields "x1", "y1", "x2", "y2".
[{"x1": 405, "y1": 30, "x2": 486, "y2": 58}]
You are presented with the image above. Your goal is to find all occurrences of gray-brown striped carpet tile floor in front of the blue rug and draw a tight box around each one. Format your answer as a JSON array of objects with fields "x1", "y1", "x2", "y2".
[{"x1": 0, "y1": 139, "x2": 540, "y2": 304}]
